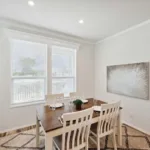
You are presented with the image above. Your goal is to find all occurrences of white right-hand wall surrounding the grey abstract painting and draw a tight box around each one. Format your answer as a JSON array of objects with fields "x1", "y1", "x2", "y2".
[{"x1": 95, "y1": 20, "x2": 150, "y2": 133}]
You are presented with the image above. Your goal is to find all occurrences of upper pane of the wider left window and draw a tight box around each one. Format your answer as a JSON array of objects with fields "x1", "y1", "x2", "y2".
[{"x1": 11, "y1": 40, "x2": 47, "y2": 77}]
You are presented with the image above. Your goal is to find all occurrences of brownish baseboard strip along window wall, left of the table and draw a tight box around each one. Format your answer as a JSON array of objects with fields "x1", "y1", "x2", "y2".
[{"x1": 0, "y1": 124, "x2": 36, "y2": 138}]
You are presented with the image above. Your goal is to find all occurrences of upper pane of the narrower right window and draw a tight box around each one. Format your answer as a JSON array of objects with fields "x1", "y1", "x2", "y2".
[{"x1": 52, "y1": 47, "x2": 75, "y2": 77}]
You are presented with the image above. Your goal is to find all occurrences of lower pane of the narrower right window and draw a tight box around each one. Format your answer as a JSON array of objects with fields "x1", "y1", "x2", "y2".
[{"x1": 52, "y1": 78, "x2": 75, "y2": 94}]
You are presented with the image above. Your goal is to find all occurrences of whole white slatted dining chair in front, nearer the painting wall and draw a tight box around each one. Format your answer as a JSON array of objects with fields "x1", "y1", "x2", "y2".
[{"x1": 90, "y1": 101, "x2": 120, "y2": 150}]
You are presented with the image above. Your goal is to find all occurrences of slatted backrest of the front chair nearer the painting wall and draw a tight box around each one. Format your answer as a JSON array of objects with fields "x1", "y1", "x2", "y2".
[{"x1": 97, "y1": 101, "x2": 120, "y2": 135}]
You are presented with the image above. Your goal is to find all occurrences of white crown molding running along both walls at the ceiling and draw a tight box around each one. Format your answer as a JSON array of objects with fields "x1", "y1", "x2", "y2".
[{"x1": 0, "y1": 18, "x2": 150, "y2": 45}]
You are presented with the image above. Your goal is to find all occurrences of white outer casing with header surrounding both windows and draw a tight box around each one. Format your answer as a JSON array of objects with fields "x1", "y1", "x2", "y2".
[{"x1": 3, "y1": 28, "x2": 80, "y2": 108}]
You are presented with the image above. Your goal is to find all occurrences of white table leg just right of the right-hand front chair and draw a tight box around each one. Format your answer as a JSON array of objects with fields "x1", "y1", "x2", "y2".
[{"x1": 117, "y1": 110, "x2": 122, "y2": 146}]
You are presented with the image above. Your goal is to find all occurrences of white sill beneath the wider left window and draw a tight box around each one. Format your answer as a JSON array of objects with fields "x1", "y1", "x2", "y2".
[{"x1": 10, "y1": 100, "x2": 45, "y2": 108}]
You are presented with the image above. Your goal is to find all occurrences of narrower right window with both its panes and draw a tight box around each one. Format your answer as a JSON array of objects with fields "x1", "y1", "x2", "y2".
[{"x1": 52, "y1": 46, "x2": 76, "y2": 96}]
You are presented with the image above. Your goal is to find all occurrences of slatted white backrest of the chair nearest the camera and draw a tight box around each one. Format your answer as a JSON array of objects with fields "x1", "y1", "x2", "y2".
[{"x1": 62, "y1": 108, "x2": 93, "y2": 150}]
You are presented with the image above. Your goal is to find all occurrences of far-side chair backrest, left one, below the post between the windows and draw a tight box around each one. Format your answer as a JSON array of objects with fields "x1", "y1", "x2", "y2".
[{"x1": 45, "y1": 94, "x2": 64, "y2": 105}]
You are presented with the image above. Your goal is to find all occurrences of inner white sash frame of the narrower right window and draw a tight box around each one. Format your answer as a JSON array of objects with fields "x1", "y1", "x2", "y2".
[{"x1": 51, "y1": 45, "x2": 77, "y2": 97}]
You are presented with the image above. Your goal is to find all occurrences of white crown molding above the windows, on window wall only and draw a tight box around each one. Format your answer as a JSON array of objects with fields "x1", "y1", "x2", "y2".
[{"x1": 0, "y1": 17, "x2": 95, "y2": 44}]
